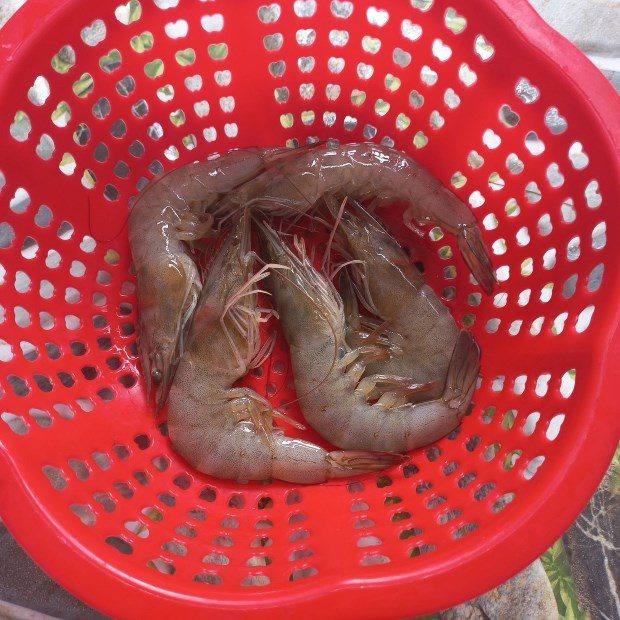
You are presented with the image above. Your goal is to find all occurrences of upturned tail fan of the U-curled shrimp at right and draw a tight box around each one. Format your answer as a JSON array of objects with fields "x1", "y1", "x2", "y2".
[{"x1": 442, "y1": 329, "x2": 480, "y2": 418}]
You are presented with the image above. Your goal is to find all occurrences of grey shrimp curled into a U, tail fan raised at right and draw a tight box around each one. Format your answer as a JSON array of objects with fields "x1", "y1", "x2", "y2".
[{"x1": 261, "y1": 225, "x2": 480, "y2": 452}]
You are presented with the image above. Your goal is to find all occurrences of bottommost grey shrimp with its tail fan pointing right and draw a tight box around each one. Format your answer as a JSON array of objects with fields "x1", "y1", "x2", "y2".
[{"x1": 168, "y1": 212, "x2": 403, "y2": 484}]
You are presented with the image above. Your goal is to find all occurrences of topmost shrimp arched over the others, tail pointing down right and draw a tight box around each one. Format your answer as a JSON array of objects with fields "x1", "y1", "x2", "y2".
[{"x1": 218, "y1": 143, "x2": 496, "y2": 293}]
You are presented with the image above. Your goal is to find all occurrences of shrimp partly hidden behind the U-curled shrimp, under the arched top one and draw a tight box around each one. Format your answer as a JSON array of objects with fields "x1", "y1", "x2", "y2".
[{"x1": 332, "y1": 196, "x2": 458, "y2": 401}]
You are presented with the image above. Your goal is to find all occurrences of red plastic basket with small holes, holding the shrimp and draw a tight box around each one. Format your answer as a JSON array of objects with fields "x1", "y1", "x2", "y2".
[{"x1": 0, "y1": 0, "x2": 620, "y2": 618}]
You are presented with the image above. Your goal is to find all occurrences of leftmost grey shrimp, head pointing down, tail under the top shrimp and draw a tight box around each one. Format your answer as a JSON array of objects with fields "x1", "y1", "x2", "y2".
[{"x1": 129, "y1": 148, "x2": 291, "y2": 410}]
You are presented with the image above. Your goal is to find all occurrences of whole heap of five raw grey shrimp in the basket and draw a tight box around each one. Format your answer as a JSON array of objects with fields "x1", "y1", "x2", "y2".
[{"x1": 129, "y1": 143, "x2": 496, "y2": 484}]
